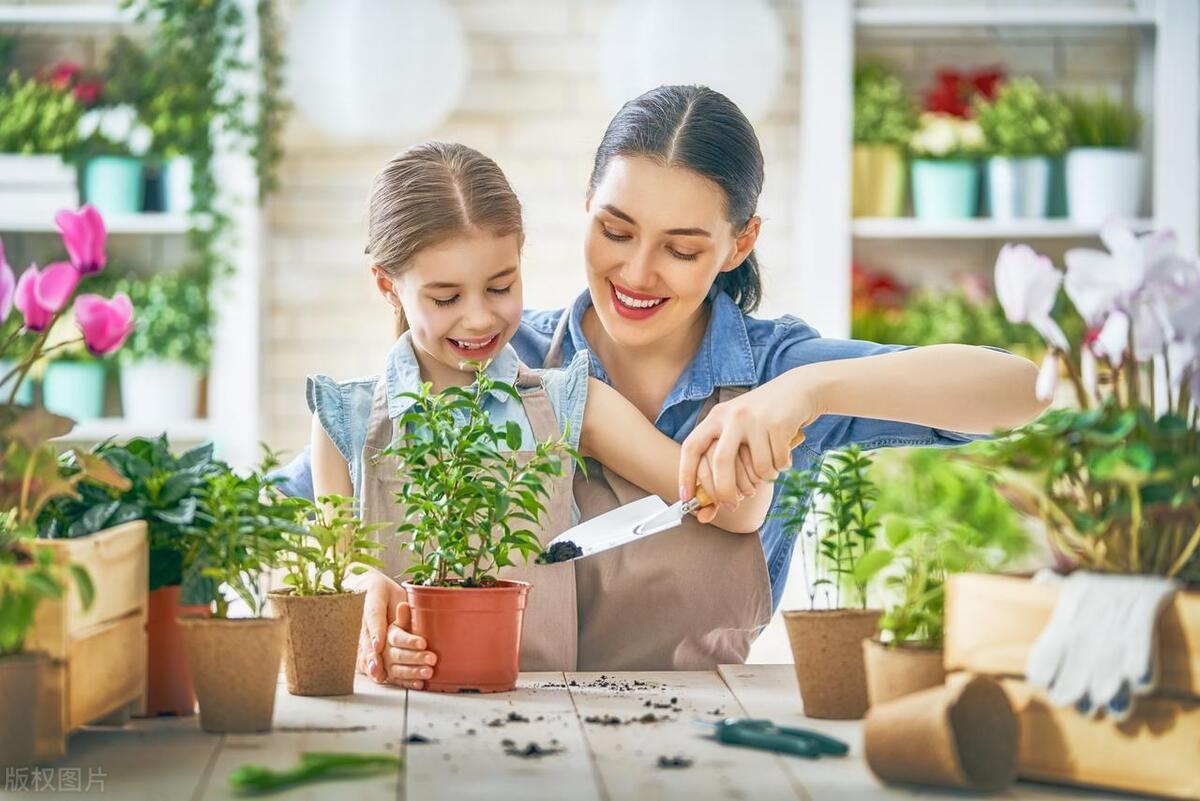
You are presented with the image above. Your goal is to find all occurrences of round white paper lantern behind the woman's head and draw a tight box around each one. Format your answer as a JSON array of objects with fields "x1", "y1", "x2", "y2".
[{"x1": 600, "y1": 0, "x2": 787, "y2": 120}]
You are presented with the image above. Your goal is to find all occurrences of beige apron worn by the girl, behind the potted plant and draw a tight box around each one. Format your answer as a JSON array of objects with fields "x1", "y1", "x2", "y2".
[{"x1": 360, "y1": 365, "x2": 576, "y2": 670}]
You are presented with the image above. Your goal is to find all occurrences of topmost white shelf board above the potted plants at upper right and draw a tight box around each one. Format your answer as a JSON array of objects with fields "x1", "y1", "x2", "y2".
[{"x1": 854, "y1": 4, "x2": 1154, "y2": 28}]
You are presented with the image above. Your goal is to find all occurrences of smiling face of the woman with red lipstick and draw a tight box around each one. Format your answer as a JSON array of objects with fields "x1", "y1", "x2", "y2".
[{"x1": 584, "y1": 157, "x2": 760, "y2": 347}]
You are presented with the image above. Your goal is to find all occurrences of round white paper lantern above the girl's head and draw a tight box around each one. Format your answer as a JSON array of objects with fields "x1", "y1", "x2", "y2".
[{"x1": 286, "y1": 0, "x2": 470, "y2": 143}]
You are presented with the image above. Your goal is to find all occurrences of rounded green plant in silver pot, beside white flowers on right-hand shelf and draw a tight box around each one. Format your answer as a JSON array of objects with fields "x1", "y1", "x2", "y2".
[{"x1": 974, "y1": 78, "x2": 1070, "y2": 157}]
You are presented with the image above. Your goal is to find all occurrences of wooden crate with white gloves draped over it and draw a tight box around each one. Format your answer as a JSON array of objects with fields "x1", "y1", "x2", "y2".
[{"x1": 946, "y1": 574, "x2": 1200, "y2": 799}]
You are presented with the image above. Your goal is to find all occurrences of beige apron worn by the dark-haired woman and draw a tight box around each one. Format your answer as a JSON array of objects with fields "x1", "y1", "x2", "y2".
[{"x1": 545, "y1": 312, "x2": 770, "y2": 670}]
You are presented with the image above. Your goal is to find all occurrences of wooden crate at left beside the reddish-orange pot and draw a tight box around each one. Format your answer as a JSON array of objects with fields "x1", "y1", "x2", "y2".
[{"x1": 25, "y1": 520, "x2": 149, "y2": 760}]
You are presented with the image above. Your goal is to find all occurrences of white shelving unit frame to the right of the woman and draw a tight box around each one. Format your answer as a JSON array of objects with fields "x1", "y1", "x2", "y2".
[{"x1": 796, "y1": 0, "x2": 1200, "y2": 336}]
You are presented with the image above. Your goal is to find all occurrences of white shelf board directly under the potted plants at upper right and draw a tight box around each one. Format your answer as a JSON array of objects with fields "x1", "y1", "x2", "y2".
[{"x1": 851, "y1": 217, "x2": 1154, "y2": 240}]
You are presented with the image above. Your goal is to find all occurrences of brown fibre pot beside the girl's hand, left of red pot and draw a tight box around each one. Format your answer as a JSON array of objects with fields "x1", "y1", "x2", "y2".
[{"x1": 268, "y1": 589, "x2": 366, "y2": 695}]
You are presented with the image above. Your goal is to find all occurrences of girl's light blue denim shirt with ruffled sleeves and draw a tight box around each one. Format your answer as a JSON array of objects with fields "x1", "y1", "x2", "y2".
[{"x1": 304, "y1": 332, "x2": 588, "y2": 514}]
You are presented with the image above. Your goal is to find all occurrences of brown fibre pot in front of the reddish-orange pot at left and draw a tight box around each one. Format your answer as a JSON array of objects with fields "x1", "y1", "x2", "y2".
[{"x1": 179, "y1": 618, "x2": 284, "y2": 733}]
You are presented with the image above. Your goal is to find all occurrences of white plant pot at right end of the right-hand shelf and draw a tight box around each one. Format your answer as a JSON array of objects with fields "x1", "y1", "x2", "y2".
[{"x1": 1067, "y1": 147, "x2": 1144, "y2": 225}]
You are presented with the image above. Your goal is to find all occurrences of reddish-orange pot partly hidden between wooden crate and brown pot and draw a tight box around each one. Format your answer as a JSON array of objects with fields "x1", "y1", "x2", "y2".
[{"x1": 145, "y1": 584, "x2": 209, "y2": 717}]
